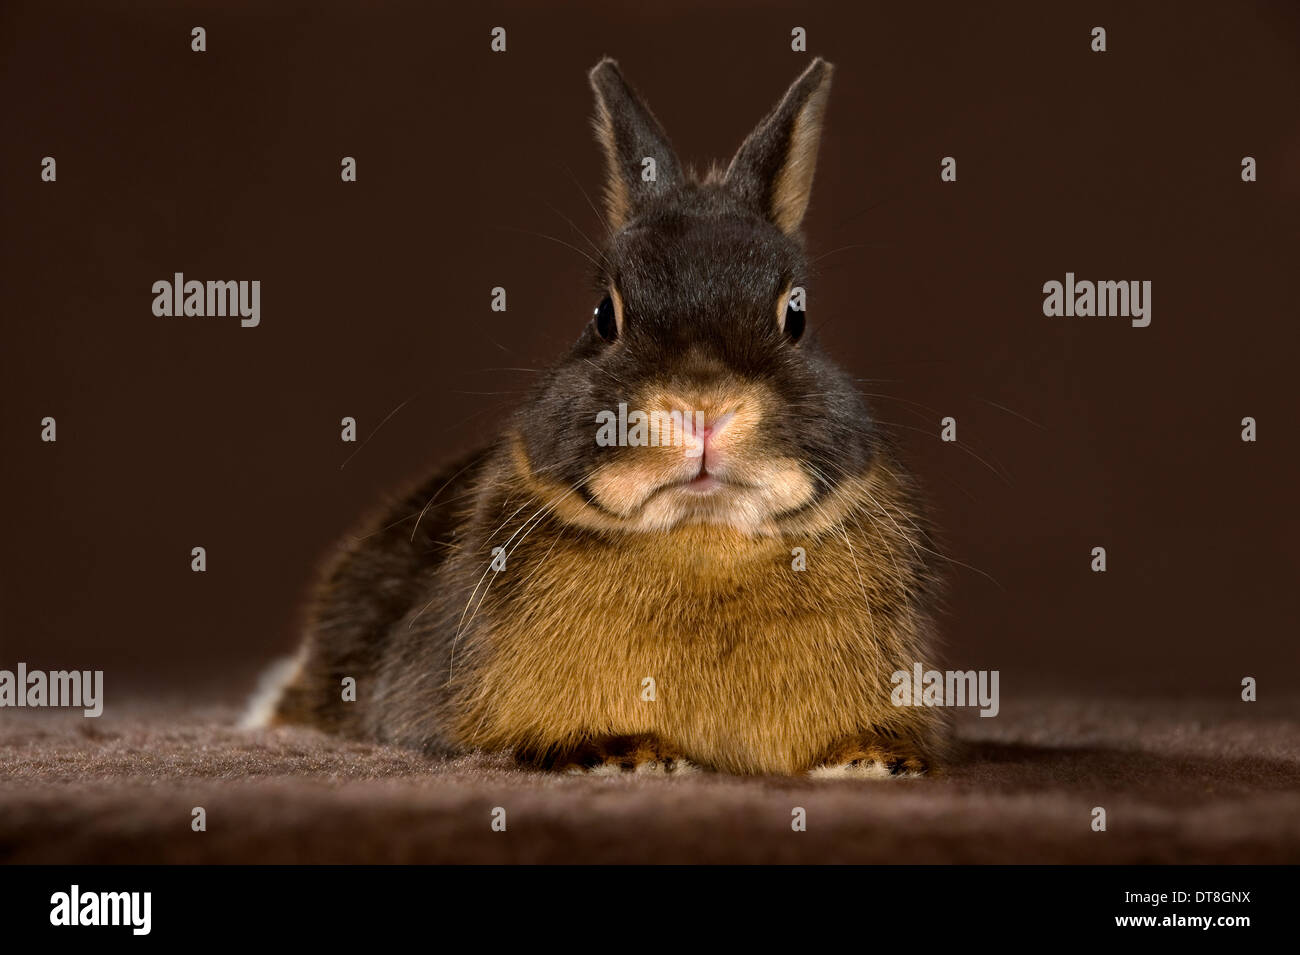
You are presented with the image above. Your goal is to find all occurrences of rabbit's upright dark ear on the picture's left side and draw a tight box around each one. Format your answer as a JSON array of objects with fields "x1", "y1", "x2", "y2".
[{"x1": 589, "y1": 57, "x2": 681, "y2": 229}]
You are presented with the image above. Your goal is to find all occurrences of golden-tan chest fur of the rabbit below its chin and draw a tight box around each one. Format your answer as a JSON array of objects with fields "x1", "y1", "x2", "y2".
[{"x1": 455, "y1": 480, "x2": 941, "y2": 773}]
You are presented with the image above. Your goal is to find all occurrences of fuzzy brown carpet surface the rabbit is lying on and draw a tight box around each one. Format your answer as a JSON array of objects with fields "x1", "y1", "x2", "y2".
[{"x1": 0, "y1": 699, "x2": 1300, "y2": 863}]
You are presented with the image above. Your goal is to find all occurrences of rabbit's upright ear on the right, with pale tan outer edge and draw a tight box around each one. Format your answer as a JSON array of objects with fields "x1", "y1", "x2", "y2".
[{"x1": 724, "y1": 57, "x2": 835, "y2": 234}]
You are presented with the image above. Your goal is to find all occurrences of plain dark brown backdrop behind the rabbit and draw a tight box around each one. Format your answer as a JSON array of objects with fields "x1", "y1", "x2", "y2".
[{"x1": 0, "y1": 0, "x2": 1300, "y2": 695}]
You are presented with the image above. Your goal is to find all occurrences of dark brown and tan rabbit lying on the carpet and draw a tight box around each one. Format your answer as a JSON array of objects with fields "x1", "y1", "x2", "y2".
[{"x1": 263, "y1": 58, "x2": 948, "y2": 777}]
